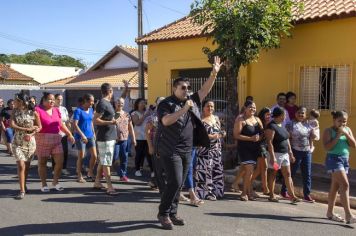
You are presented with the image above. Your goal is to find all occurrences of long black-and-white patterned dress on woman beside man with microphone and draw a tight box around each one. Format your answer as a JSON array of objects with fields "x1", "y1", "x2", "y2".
[{"x1": 195, "y1": 119, "x2": 224, "y2": 199}]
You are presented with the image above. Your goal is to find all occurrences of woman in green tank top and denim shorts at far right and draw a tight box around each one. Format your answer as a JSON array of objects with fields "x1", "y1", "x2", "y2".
[{"x1": 323, "y1": 111, "x2": 356, "y2": 224}]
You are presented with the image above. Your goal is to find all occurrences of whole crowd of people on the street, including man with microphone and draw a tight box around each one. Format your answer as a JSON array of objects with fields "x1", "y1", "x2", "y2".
[{"x1": 0, "y1": 57, "x2": 356, "y2": 229}]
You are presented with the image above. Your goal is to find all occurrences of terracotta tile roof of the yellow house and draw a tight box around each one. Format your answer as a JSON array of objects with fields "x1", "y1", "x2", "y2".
[{"x1": 136, "y1": 0, "x2": 356, "y2": 44}]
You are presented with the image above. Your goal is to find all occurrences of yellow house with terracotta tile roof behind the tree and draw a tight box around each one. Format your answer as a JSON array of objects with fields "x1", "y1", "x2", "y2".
[{"x1": 137, "y1": 0, "x2": 356, "y2": 167}]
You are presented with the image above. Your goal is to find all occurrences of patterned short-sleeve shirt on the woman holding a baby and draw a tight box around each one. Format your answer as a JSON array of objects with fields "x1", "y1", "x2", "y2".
[{"x1": 286, "y1": 121, "x2": 312, "y2": 152}]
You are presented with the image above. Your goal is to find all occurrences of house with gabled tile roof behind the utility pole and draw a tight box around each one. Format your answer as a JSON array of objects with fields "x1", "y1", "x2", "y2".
[{"x1": 41, "y1": 46, "x2": 147, "y2": 107}]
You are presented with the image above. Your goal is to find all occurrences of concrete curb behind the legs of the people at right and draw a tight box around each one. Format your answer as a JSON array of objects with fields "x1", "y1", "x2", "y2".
[{"x1": 225, "y1": 168, "x2": 356, "y2": 209}]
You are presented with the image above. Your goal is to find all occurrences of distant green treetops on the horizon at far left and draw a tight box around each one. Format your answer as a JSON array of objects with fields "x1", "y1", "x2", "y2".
[{"x1": 0, "y1": 49, "x2": 85, "y2": 68}]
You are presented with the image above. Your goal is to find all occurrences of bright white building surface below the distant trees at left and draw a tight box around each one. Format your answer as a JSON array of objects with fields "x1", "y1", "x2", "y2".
[{"x1": 9, "y1": 64, "x2": 82, "y2": 84}]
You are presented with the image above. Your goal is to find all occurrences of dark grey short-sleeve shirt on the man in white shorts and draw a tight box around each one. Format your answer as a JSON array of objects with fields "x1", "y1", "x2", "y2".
[{"x1": 95, "y1": 98, "x2": 117, "y2": 142}]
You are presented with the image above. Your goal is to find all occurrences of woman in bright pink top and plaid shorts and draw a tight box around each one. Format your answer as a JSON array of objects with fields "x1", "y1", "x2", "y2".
[{"x1": 35, "y1": 92, "x2": 75, "y2": 192}]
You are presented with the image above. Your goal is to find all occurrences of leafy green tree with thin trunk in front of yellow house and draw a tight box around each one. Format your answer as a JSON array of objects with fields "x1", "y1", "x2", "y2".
[{"x1": 190, "y1": 0, "x2": 298, "y2": 140}]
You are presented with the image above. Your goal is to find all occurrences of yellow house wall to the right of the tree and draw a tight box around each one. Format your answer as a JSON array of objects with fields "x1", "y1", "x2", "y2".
[{"x1": 246, "y1": 17, "x2": 356, "y2": 167}]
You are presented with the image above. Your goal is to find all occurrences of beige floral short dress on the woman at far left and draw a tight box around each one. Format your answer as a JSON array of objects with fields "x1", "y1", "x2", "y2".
[{"x1": 12, "y1": 109, "x2": 36, "y2": 161}]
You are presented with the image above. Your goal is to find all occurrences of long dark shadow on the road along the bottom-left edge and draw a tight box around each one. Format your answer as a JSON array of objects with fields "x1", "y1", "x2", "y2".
[{"x1": 0, "y1": 220, "x2": 161, "y2": 236}]
